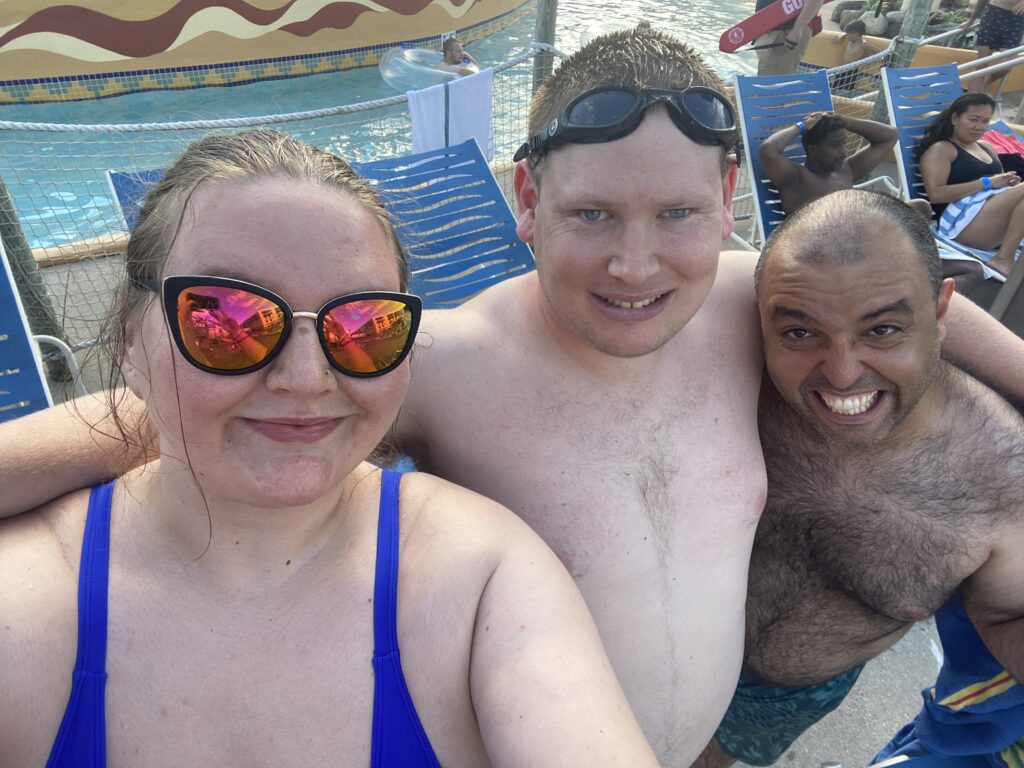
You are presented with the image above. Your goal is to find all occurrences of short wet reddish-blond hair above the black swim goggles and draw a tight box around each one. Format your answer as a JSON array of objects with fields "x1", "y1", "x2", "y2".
[{"x1": 529, "y1": 22, "x2": 737, "y2": 178}]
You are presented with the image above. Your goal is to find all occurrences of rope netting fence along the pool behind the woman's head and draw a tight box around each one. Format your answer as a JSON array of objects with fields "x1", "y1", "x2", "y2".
[{"x1": 0, "y1": 45, "x2": 560, "y2": 382}]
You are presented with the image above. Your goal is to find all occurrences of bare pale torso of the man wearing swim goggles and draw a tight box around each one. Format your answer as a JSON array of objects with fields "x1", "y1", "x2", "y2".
[{"x1": 403, "y1": 262, "x2": 765, "y2": 766}]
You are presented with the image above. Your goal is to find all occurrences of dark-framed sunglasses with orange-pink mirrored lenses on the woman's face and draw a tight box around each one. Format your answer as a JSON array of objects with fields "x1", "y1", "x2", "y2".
[{"x1": 147, "y1": 275, "x2": 422, "y2": 377}]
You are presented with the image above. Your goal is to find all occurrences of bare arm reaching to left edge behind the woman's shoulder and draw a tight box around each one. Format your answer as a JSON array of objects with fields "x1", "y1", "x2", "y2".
[{"x1": 0, "y1": 391, "x2": 150, "y2": 517}]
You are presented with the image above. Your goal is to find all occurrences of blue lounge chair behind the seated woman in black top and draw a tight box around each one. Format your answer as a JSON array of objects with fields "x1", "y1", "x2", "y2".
[{"x1": 882, "y1": 63, "x2": 1004, "y2": 282}]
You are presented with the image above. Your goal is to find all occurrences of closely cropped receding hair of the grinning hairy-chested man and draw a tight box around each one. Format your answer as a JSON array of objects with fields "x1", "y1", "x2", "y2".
[{"x1": 754, "y1": 189, "x2": 942, "y2": 298}]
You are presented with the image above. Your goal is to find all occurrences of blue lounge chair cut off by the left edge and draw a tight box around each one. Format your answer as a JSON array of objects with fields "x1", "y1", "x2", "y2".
[{"x1": 0, "y1": 243, "x2": 53, "y2": 422}]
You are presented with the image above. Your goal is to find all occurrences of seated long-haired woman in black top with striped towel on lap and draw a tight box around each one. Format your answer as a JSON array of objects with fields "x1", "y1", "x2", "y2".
[{"x1": 918, "y1": 93, "x2": 1024, "y2": 273}]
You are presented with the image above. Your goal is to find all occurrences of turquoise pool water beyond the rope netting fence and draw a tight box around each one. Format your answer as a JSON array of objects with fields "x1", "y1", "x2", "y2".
[{"x1": 0, "y1": 0, "x2": 756, "y2": 248}]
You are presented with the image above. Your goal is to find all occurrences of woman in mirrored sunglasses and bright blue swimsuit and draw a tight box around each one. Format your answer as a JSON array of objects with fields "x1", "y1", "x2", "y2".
[{"x1": 0, "y1": 131, "x2": 655, "y2": 768}]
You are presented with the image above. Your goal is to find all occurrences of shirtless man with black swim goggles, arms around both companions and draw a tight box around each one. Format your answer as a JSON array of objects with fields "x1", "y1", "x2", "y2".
[{"x1": 6, "y1": 25, "x2": 1024, "y2": 766}]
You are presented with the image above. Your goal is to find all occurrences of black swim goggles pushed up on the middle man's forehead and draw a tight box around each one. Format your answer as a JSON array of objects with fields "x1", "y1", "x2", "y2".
[{"x1": 513, "y1": 85, "x2": 736, "y2": 163}]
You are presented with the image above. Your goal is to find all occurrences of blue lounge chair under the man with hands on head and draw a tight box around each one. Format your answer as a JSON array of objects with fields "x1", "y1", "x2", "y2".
[{"x1": 735, "y1": 70, "x2": 899, "y2": 243}]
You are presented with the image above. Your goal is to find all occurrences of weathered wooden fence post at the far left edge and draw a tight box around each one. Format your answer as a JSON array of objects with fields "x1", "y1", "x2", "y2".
[{"x1": 0, "y1": 173, "x2": 70, "y2": 381}]
